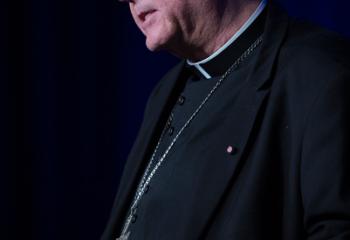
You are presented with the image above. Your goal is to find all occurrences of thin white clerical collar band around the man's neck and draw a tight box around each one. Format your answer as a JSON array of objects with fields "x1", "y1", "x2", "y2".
[{"x1": 187, "y1": 0, "x2": 267, "y2": 79}]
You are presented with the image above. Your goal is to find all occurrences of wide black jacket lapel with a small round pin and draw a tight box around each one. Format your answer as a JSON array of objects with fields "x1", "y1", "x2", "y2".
[{"x1": 175, "y1": 5, "x2": 288, "y2": 236}]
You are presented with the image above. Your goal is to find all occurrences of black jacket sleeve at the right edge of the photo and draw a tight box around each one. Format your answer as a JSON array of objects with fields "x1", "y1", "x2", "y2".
[{"x1": 300, "y1": 70, "x2": 350, "y2": 240}]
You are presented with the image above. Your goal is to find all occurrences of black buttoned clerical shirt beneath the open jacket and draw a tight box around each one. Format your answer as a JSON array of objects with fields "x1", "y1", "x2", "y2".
[{"x1": 125, "y1": 7, "x2": 265, "y2": 239}]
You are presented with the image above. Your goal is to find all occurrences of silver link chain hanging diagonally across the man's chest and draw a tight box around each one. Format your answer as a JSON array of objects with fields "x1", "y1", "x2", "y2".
[{"x1": 117, "y1": 36, "x2": 263, "y2": 240}]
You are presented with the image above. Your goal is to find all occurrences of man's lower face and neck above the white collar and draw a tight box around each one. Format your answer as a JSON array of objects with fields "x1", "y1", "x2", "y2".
[{"x1": 128, "y1": 0, "x2": 260, "y2": 62}]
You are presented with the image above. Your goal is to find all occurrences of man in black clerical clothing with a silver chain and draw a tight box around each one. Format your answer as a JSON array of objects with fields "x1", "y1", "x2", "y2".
[{"x1": 102, "y1": 0, "x2": 350, "y2": 240}]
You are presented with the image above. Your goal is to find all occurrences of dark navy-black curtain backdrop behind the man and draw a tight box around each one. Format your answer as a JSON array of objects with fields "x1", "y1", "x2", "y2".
[{"x1": 0, "y1": 0, "x2": 350, "y2": 240}]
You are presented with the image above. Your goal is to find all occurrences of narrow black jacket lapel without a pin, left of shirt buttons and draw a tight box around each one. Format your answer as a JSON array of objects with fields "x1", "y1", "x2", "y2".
[{"x1": 105, "y1": 61, "x2": 186, "y2": 237}]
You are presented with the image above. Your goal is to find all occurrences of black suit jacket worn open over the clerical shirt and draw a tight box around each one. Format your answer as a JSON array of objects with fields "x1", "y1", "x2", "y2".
[{"x1": 102, "y1": 2, "x2": 350, "y2": 240}]
